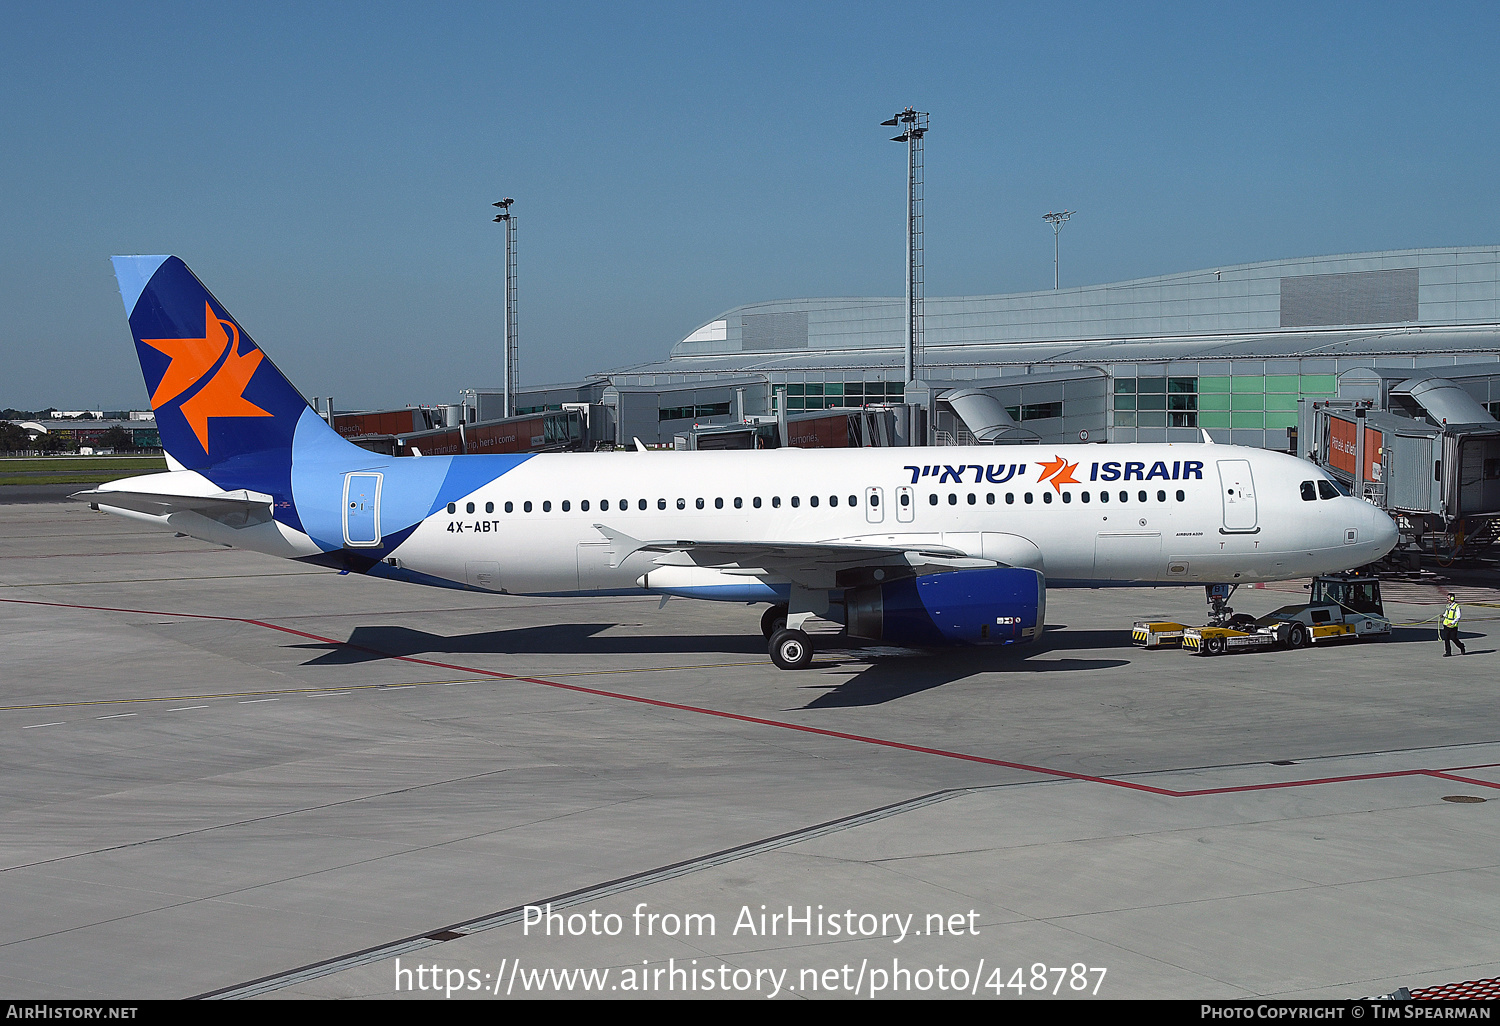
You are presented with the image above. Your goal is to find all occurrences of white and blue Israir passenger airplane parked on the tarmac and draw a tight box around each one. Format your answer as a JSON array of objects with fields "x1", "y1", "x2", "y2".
[{"x1": 74, "y1": 257, "x2": 1397, "y2": 669}]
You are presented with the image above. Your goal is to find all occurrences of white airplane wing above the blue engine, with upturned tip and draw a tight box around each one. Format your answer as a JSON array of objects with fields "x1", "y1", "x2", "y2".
[{"x1": 594, "y1": 524, "x2": 999, "y2": 588}]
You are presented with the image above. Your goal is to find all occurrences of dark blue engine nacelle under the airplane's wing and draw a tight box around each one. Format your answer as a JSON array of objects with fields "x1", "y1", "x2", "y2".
[{"x1": 845, "y1": 567, "x2": 1047, "y2": 645}]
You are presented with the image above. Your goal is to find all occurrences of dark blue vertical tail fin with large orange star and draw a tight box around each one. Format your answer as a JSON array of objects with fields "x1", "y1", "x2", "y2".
[{"x1": 114, "y1": 257, "x2": 368, "y2": 521}]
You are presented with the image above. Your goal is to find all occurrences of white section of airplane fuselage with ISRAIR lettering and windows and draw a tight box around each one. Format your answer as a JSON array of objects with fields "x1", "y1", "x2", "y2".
[{"x1": 381, "y1": 444, "x2": 1395, "y2": 597}]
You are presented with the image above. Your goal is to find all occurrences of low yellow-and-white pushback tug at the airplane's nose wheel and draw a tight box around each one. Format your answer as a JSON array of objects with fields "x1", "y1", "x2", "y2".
[{"x1": 1182, "y1": 573, "x2": 1391, "y2": 656}]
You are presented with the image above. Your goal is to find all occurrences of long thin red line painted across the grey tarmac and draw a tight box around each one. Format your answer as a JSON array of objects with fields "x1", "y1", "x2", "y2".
[{"x1": 0, "y1": 599, "x2": 1500, "y2": 798}]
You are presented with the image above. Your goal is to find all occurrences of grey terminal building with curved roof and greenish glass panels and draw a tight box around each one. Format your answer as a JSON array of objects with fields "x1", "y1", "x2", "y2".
[{"x1": 546, "y1": 246, "x2": 1500, "y2": 452}]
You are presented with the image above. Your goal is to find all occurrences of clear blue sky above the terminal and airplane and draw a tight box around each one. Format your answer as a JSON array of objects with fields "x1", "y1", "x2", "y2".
[{"x1": 0, "y1": 2, "x2": 1500, "y2": 408}]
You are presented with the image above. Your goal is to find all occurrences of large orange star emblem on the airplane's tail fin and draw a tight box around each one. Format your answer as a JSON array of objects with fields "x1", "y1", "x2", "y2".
[{"x1": 141, "y1": 303, "x2": 273, "y2": 453}]
